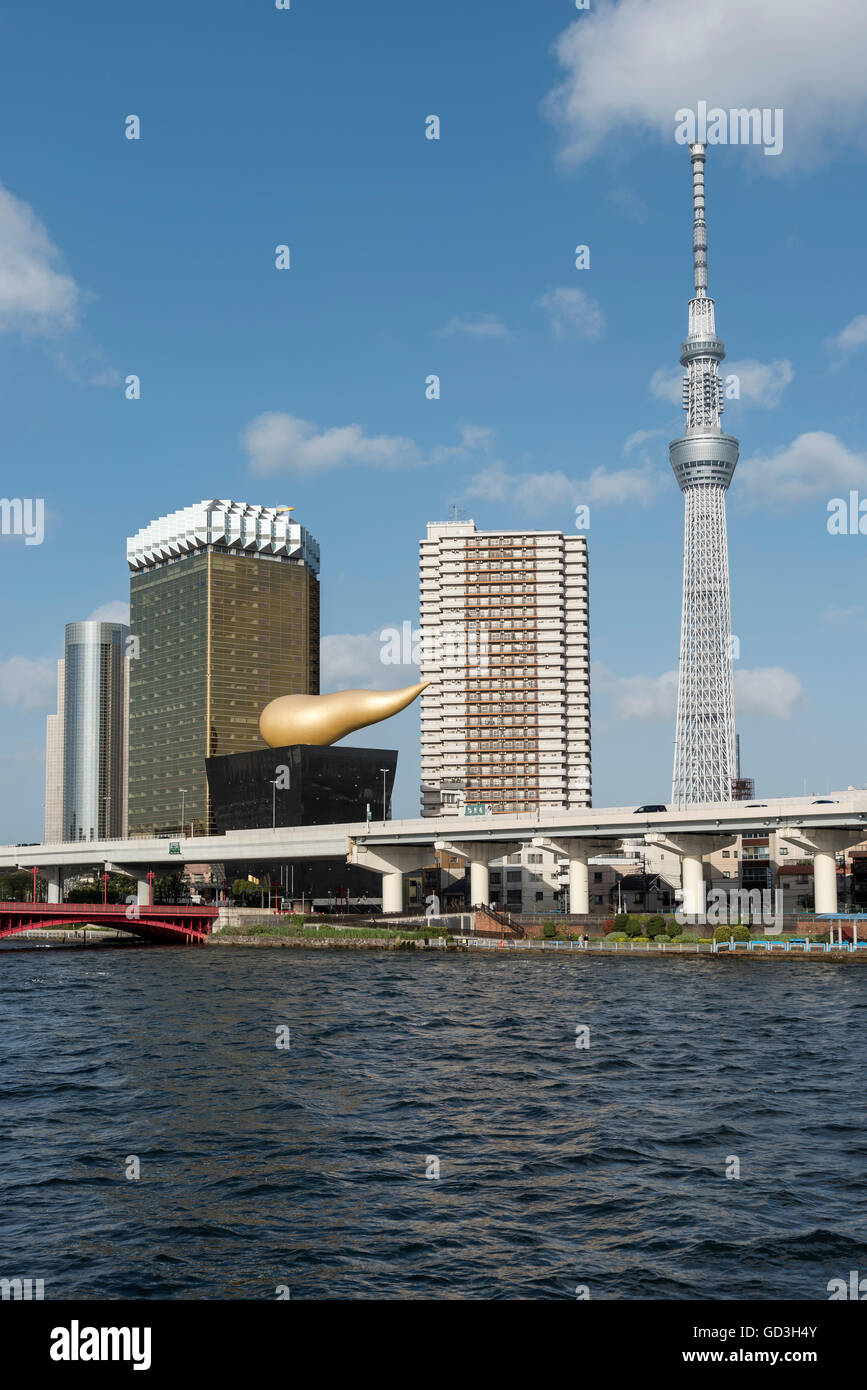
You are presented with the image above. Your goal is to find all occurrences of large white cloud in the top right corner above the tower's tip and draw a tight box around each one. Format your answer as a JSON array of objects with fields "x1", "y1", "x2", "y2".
[{"x1": 546, "y1": 0, "x2": 867, "y2": 174}]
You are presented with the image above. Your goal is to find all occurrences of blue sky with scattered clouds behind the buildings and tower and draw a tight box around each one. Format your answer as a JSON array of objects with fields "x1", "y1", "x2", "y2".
[{"x1": 0, "y1": 0, "x2": 867, "y2": 841}]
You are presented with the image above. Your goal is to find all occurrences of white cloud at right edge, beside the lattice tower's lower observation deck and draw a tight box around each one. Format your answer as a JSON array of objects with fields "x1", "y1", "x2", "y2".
[{"x1": 735, "y1": 430, "x2": 867, "y2": 507}]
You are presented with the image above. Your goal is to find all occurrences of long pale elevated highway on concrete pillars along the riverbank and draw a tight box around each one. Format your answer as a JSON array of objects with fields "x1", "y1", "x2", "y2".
[{"x1": 0, "y1": 790, "x2": 867, "y2": 912}]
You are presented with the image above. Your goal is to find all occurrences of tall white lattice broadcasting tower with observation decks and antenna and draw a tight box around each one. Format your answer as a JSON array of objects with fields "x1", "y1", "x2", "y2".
[{"x1": 668, "y1": 145, "x2": 738, "y2": 808}]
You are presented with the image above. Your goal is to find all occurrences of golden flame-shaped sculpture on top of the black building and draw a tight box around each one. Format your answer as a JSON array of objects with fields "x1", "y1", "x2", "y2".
[{"x1": 258, "y1": 681, "x2": 431, "y2": 748}]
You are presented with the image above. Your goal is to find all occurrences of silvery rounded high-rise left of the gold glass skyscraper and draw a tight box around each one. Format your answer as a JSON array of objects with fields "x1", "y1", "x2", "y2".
[{"x1": 44, "y1": 621, "x2": 129, "y2": 844}]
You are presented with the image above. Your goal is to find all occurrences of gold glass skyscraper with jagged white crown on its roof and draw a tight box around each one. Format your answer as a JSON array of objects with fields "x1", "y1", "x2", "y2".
[{"x1": 126, "y1": 500, "x2": 320, "y2": 835}]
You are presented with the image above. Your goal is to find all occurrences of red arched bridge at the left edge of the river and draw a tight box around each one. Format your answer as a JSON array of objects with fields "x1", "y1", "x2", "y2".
[{"x1": 0, "y1": 902, "x2": 220, "y2": 945}]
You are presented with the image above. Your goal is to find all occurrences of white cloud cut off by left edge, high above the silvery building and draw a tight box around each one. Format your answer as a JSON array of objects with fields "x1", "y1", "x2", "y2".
[{"x1": 0, "y1": 185, "x2": 82, "y2": 336}]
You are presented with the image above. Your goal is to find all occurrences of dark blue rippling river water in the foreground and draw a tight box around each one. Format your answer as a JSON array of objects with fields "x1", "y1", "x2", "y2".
[{"x1": 0, "y1": 948, "x2": 867, "y2": 1298}]
